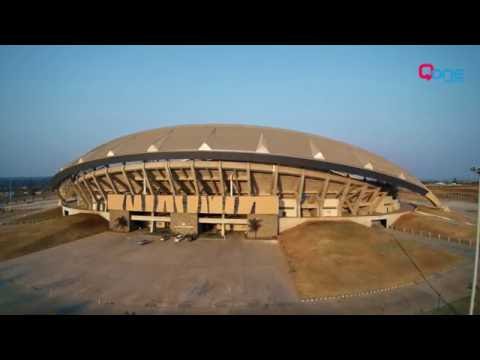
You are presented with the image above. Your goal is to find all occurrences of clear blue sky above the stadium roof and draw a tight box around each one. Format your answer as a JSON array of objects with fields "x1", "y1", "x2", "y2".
[{"x1": 0, "y1": 45, "x2": 480, "y2": 179}]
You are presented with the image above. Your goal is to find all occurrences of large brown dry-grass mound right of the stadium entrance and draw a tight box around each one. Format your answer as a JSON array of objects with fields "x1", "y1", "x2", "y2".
[{"x1": 279, "y1": 222, "x2": 462, "y2": 298}]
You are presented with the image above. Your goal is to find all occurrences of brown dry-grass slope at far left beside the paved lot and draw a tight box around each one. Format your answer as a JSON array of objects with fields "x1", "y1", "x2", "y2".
[{"x1": 0, "y1": 209, "x2": 108, "y2": 261}]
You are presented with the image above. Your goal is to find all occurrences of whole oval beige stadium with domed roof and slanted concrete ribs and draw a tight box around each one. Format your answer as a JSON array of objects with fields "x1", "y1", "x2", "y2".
[{"x1": 52, "y1": 124, "x2": 441, "y2": 238}]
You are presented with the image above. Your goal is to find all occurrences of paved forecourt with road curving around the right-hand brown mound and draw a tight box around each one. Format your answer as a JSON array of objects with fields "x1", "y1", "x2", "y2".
[{"x1": 0, "y1": 230, "x2": 473, "y2": 314}]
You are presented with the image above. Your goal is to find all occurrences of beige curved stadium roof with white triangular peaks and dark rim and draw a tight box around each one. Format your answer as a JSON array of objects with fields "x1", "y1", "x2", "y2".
[{"x1": 54, "y1": 124, "x2": 427, "y2": 193}]
